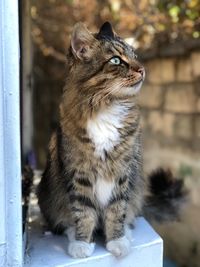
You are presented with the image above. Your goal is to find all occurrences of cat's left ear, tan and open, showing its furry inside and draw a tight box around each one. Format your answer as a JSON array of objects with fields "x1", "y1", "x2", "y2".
[{"x1": 71, "y1": 22, "x2": 96, "y2": 60}]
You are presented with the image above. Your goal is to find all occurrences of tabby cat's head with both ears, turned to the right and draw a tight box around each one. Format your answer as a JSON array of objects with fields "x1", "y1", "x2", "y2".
[{"x1": 68, "y1": 22, "x2": 145, "y2": 100}]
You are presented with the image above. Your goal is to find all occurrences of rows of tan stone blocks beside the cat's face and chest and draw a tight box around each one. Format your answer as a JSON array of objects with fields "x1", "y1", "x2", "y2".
[{"x1": 140, "y1": 52, "x2": 200, "y2": 151}]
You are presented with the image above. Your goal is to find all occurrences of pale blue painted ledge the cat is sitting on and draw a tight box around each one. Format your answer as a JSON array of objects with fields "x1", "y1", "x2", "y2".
[{"x1": 25, "y1": 217, "x2": 163, "y2": 267}]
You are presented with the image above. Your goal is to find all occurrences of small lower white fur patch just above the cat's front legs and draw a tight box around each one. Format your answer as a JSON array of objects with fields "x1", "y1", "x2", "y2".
[{"x1": 94, "y1": 178, "x2": 114, "y2": 206}]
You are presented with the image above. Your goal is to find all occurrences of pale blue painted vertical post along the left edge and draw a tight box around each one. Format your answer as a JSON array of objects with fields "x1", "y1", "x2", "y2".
[{"x1": 0, "y1": 0, "x2": 23, "y2": 267}]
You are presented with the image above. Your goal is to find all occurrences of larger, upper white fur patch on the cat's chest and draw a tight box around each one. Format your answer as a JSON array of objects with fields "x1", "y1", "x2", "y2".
[{"x1": 87, "y1": 104, "x2": 127, "y2": 159}]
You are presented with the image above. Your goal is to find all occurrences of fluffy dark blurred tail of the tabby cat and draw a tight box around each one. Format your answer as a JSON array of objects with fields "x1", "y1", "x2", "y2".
[{"x1": 143, "y1": 169, "x2": 188, "y2": 222}]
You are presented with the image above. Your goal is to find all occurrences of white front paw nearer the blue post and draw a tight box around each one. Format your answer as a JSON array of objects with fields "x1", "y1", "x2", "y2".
[{"x1": 68, "y1": 240, "x2": 95, "y2": 258}]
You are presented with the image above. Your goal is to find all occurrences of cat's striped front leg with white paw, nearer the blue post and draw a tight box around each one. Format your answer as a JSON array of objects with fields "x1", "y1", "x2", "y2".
[{"x1": 66, "y1": 194, "x2": 97, "y2": 258}]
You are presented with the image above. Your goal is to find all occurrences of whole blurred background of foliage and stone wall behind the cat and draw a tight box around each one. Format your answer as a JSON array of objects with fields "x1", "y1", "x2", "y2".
[{"x1": 21, "y1": 0, "x2": 200, "y2": 267}]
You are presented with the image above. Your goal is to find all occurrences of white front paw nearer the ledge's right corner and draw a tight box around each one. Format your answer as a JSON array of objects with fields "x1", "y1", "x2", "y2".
[{"x1": 106, "y1": 236, "x2": 131, "y2": 257}]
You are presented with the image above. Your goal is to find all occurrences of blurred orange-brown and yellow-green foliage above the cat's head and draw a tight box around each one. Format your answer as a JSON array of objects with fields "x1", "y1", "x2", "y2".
[{"x1": 31, "y1": 0, "x2": 200, "y2": 60}]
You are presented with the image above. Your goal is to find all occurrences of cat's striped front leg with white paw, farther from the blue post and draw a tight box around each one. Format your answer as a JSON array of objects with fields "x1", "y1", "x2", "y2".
[{"x1": 105, "y1": 199, "x2": 131, "y2": 257}]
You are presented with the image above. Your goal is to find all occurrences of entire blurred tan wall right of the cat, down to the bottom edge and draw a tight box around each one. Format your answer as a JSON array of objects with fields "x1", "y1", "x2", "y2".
[{"x1": 140, "y1": 50, "x2": 200, "y2": 267}]
